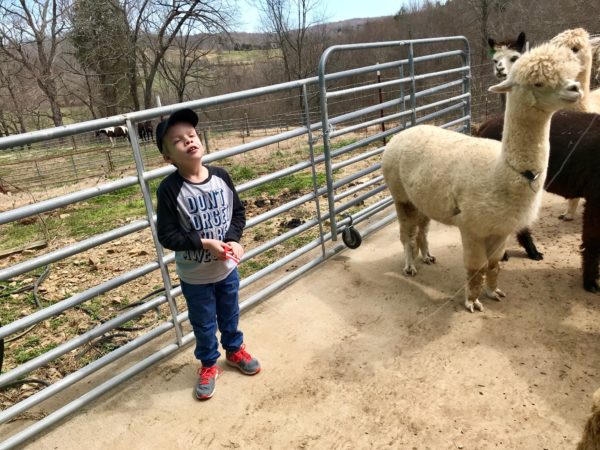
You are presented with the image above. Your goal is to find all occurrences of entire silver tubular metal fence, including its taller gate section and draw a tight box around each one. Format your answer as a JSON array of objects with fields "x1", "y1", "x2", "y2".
[{"x1": 0, "y1": 37, "x2": 470, "y2": 449}]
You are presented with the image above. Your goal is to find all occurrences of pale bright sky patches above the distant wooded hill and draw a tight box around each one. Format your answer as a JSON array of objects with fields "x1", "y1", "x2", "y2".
[{"x1": 236, "y1": 0, "x2": 402, "y2": 33}]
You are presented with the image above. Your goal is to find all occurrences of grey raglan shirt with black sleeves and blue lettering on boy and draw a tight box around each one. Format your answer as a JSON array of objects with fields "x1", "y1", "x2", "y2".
[{"x1": 156, "y1": 166, "x2": 246, "y2": 284}]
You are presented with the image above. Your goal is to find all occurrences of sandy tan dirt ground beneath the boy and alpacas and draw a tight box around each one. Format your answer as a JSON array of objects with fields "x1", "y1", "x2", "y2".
[{"x1": 9, "y1": 195, "x2": 600, "y2": 450}]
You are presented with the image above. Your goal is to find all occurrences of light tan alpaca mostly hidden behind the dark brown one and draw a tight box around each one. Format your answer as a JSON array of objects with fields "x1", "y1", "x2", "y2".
[{"x1": 550, "y1": 28, "x2": 600, "y2": 221}]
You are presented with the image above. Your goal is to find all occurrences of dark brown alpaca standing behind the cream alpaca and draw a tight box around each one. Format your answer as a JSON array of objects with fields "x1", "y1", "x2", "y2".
[{"x1": 477, "y1": 111, "x2": 600, "y2": 292}]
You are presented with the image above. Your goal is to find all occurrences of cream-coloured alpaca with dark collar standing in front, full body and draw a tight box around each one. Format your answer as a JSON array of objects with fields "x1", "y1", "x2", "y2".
[{"x1": 383, "y1": 44, "x2": 582, "y2": 312}]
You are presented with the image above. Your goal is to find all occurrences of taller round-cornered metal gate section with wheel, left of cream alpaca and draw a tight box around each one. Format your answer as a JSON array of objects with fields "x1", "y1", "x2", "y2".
[{"x1": 319, "y1": 37, "x2": 471, "y2": 241}]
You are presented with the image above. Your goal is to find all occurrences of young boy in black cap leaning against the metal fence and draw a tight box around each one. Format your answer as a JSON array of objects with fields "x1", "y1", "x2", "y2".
[{"x1": 156, "y1": 109, "x2": 260, "y2": 400}]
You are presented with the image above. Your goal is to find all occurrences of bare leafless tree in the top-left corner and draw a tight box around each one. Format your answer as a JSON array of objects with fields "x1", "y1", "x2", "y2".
[{"x1": 0, "y1": 0, "x2": 68, "y2": 126}]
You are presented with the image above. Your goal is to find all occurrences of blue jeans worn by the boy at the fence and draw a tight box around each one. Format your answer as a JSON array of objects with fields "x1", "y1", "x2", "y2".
[{"x1": 181, "y1": 269, "x2": 244, "y2": 367}]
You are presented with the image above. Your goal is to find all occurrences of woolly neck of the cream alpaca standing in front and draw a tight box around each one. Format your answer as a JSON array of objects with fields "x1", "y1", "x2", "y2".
[{"x1": 502, "y1": 92, "x2": 553, "y2": 174}]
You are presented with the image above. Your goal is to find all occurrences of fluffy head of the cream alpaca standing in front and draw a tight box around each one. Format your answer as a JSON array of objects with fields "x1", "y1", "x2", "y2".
[{"x1": 489, "y1": 43, "x2": 583, "y2": 112}]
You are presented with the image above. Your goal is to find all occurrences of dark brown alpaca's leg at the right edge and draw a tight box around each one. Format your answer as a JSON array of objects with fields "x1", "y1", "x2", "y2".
[{"x1": 581, "y1": 199, "x2": 600, "y2": 292}]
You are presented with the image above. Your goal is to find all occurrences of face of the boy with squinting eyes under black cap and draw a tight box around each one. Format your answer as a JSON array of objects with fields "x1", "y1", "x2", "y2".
[{"x1": 163, "y1": 122, "x2": 204, "y2": 167}]
